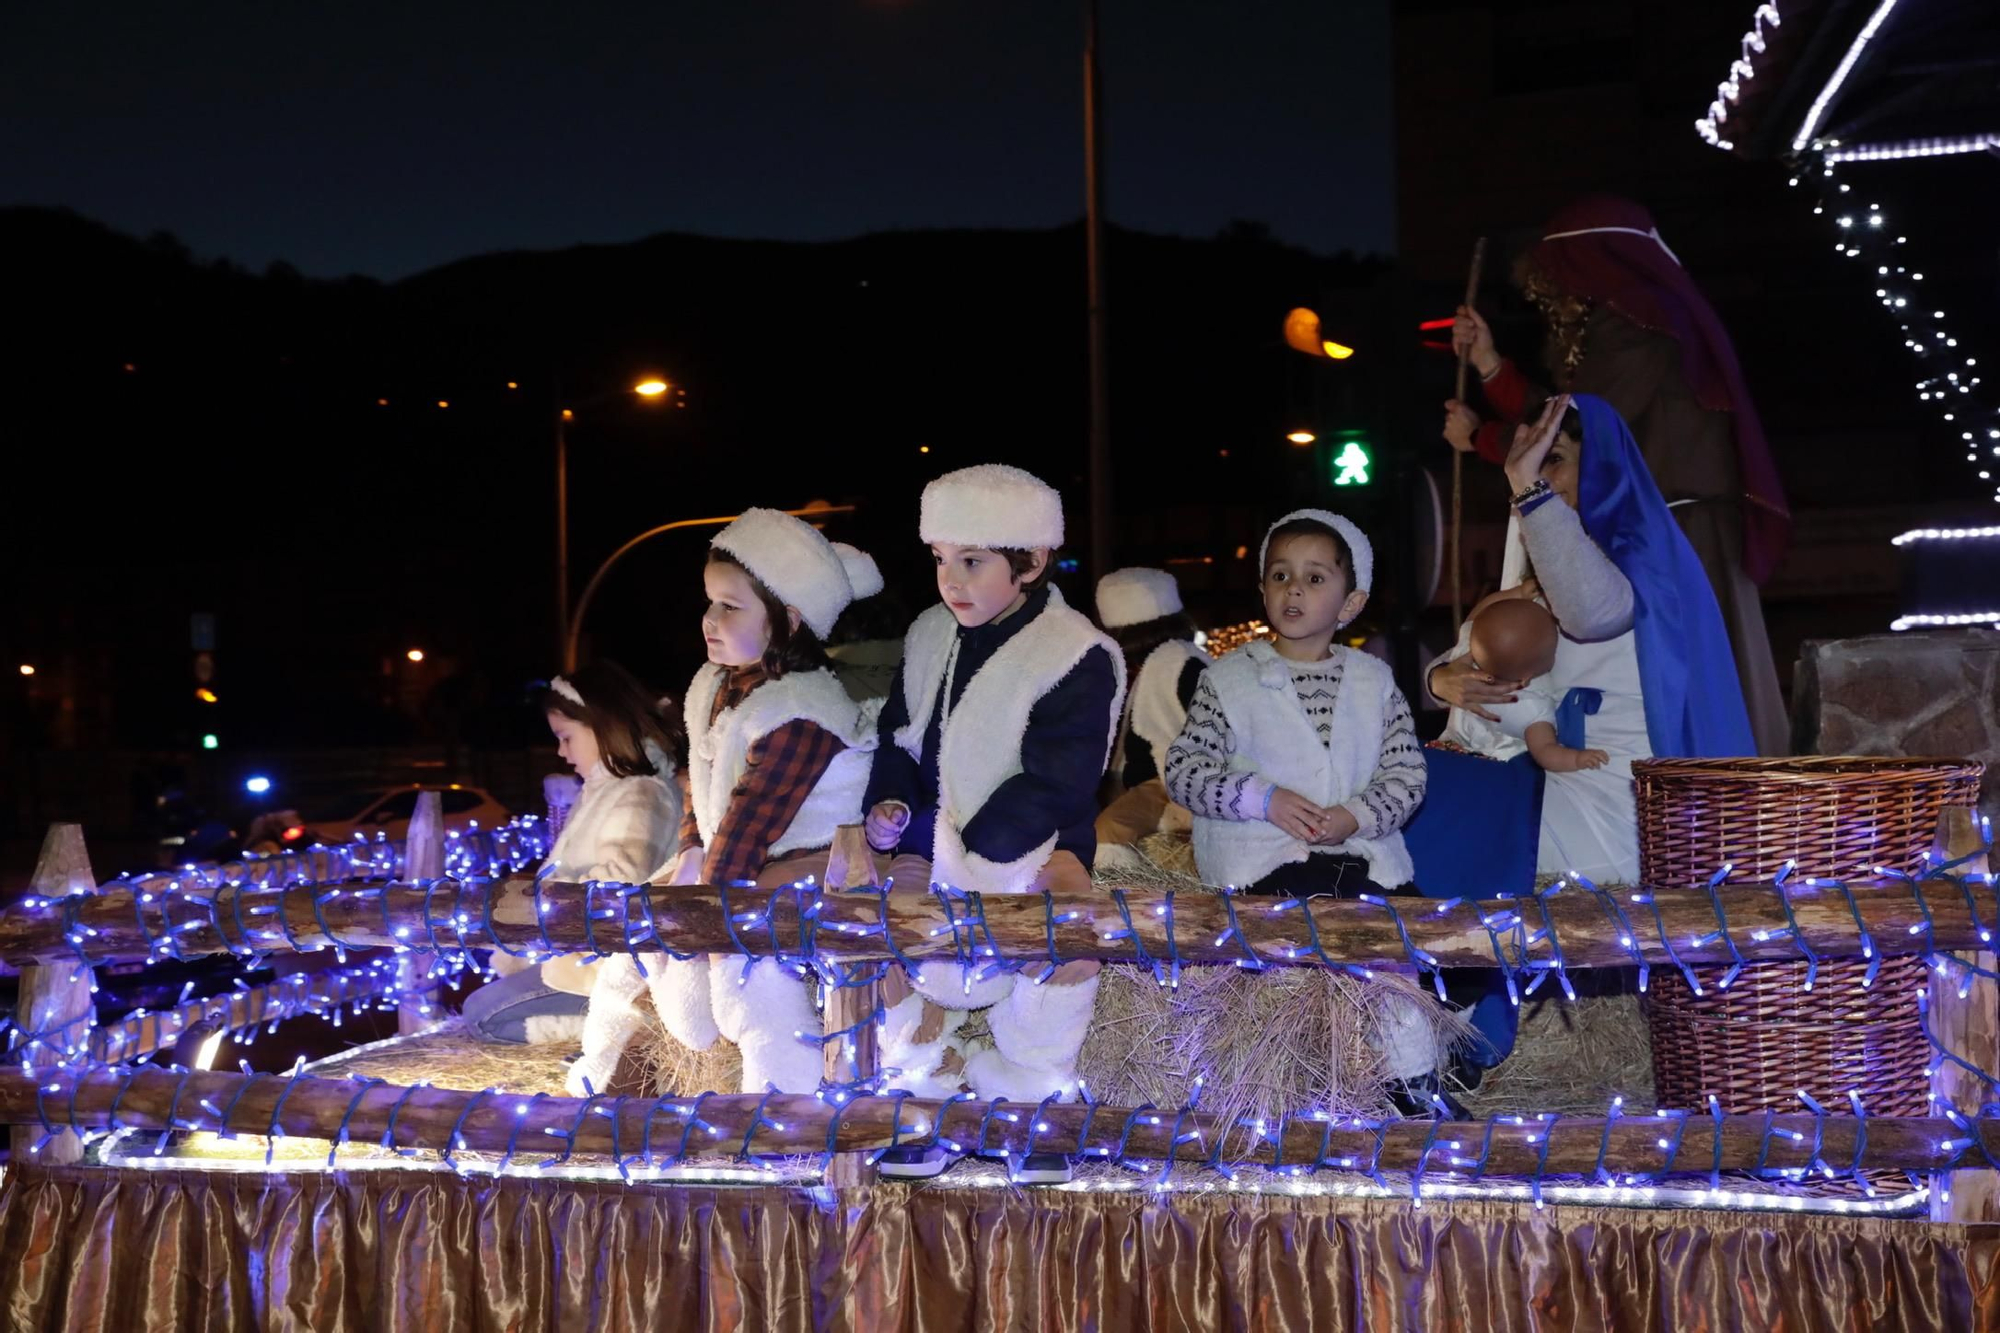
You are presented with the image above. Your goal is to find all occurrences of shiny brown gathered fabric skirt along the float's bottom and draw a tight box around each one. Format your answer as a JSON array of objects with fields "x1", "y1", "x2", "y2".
[{"x1": 0, "y1": 1167, "x2": 2000, "y2": 1333}]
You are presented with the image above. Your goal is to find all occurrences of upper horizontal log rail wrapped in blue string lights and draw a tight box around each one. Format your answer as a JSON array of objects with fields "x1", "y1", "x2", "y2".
[{"x1": 0, "y1": 860, "x2": 1996, "y2": 969}]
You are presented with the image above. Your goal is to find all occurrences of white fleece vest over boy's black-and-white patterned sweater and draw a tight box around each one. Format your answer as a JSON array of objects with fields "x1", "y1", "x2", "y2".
[{"x1": 1194, "y1": 640, "x2": 1414, "y2": 889}]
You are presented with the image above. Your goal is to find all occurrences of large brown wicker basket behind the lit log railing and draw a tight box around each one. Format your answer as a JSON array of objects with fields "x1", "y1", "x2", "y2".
[{"x1": 1632, "y1": 757, "x2": 1984, "y2": 1115}]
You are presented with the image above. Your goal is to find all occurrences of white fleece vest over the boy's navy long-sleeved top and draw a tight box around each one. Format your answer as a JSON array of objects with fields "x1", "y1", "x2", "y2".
[{"x1": 896, "y1": 588, "x2": 1126, "y2": 893}]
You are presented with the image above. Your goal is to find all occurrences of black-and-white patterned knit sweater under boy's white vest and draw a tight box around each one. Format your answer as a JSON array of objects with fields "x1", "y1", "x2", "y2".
[{"x1": 1166, "y1": 658, "x2": 1426, "y2": 839}]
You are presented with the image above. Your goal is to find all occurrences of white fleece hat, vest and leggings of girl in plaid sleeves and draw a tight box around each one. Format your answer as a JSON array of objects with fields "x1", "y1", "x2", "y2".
[{"x1": 652, "y1": 508, "x2": 882, "y2": 1093}]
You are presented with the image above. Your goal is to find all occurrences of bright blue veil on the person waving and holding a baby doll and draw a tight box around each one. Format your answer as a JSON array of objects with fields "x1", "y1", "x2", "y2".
[{"x1": 1572, "y1": 394, "x2": 1756, "y2": 759}]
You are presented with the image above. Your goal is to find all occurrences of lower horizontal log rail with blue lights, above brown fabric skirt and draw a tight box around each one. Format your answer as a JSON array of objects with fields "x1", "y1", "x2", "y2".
[{"x1": 0, "y1": 1067, "x2": 2000, "y2": 1181}]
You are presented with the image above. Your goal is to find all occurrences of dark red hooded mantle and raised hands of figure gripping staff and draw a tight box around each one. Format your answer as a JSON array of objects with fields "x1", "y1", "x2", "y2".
[{"x1": 1444, "y1": 196, "x2": 1792, "y2": 755}]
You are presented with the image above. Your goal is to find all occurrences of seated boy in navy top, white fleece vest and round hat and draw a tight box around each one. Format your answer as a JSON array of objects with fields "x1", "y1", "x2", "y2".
[{"x1": 868, "y1": 464, "x2": 1124, "y2": 1183}]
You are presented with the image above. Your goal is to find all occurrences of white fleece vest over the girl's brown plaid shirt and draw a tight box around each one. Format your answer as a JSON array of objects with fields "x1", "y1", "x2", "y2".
[{"x1": 686, "y1": 662, "x2": 876, "y2": 857}]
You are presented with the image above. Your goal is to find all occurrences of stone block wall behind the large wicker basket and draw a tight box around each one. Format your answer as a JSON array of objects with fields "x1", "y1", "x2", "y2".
[{"x1": 1792, "y1": 628, "x2": 2000, "y2": 821}]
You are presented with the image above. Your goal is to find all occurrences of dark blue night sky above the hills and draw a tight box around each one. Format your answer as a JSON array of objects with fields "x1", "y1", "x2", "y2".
[{"x1": 0, "y1": 0, "x2": 1394, "y2": 278}]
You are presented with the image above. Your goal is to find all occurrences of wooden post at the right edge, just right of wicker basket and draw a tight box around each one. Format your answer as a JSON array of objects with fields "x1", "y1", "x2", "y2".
[{"x1": 1930, "y1": 807, "x2": 2000, "y2": 1223}]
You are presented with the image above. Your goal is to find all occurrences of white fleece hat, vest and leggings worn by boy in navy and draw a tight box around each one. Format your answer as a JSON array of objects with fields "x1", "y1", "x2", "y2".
[{"x1": 882, "y1": 464, "x2": 1124, "y2": 1101}]
